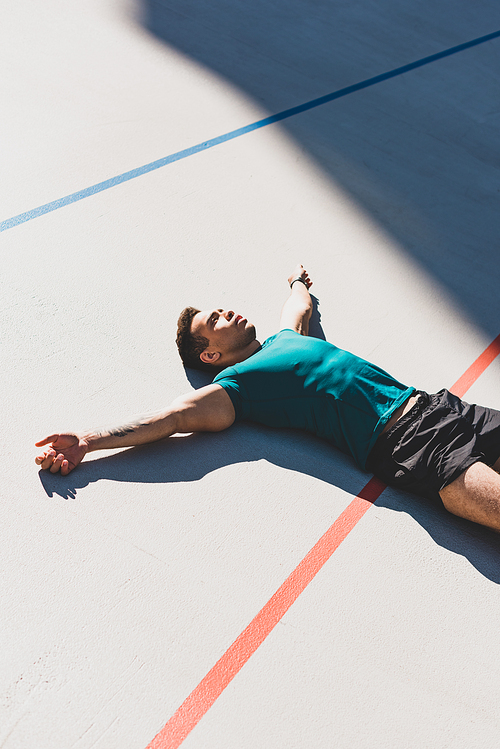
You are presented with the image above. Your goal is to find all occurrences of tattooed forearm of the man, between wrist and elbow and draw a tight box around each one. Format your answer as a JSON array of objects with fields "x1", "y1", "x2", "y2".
[{"x1": 82, "y1": 408, "x2": 182, "y2": 452}]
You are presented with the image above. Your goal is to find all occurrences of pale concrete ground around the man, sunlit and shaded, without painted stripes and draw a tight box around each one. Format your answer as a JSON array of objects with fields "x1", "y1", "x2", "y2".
[{"x1": 0, "y1": 0, "x2": 500, "y2": 749}]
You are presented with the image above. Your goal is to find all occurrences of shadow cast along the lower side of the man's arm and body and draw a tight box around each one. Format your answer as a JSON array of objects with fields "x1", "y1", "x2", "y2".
[{"x1": 39, "y1": 424, "x2": 500, "y2": 583}]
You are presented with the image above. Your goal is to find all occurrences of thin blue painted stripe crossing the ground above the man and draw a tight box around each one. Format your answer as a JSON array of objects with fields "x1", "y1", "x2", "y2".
[{"x1": 0, "y1": 31, "x2": 500, "y2": 231}]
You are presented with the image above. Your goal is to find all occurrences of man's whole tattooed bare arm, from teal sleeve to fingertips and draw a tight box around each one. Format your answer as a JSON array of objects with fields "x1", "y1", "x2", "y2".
[{"x1": 35, "y1": 385, "x2": 235, "y2": 476}]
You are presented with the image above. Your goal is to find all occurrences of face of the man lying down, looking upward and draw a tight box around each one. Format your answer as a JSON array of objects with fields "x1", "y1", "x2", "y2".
[{"x1": 191, "y1": 309, "x2": 256, "y2": 359}]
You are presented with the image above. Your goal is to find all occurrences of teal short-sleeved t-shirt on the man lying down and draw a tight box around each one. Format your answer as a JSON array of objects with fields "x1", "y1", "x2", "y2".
[{"x1": 214, "y1": 330, "x2": 415, "y2": 468}]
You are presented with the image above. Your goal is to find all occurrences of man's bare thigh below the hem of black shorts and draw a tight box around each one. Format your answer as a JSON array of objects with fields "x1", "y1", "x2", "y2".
[{"x1": 439, "y1": 459, "x2": 500, "y2": 531}]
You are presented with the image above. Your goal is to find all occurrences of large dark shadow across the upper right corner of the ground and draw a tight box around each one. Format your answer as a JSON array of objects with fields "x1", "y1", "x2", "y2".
[{"x1": 137, "y1": 0, "x2": 500, "y2": 338}]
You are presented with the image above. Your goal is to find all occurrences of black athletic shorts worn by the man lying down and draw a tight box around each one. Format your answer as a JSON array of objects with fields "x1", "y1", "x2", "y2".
[{"x1": 367, "y1": 390, "x2": 500, "y2": 500}]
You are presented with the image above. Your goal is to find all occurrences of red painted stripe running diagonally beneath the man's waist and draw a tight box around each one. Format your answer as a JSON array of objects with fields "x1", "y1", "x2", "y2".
[{"x1": 146, "y1": 335, "x2": 500, "y2": 749}]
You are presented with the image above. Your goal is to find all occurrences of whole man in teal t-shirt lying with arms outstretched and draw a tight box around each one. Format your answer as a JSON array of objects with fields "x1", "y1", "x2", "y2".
[{"x1": 36, "y1": 265, "x2": 500, "y2": 530}]
